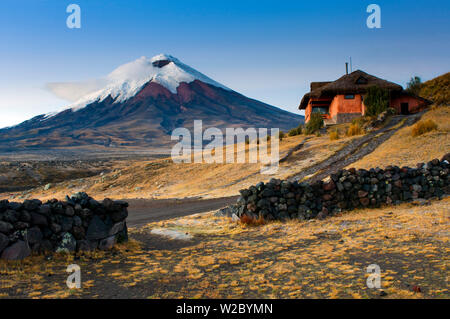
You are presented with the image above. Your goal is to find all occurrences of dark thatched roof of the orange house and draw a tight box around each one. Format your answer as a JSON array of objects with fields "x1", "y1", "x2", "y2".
[{"x1": 299, "y1": 70, "x2": 403, "y2": 109}]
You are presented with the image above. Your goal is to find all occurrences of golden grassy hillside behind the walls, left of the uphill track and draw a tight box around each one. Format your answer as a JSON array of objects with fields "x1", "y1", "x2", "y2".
[{"x1": 4, "y1": 135, "x2": 354, "y2": 200}]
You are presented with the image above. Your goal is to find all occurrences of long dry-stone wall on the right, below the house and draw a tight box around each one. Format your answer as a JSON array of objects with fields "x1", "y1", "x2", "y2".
[{"x1": 217, "y1": 154, "x2": 450, "y2": 220}]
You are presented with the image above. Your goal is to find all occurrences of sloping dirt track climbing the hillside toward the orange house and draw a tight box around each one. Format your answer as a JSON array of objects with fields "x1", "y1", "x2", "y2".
[{"x1": 289, "y1": 113, "x2": 423, "y2": 182}]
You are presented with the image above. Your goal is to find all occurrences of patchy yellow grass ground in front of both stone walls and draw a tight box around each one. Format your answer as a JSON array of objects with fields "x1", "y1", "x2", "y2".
[{"x1": 0, "y1": 198, "x2": 450, "y2": 298}]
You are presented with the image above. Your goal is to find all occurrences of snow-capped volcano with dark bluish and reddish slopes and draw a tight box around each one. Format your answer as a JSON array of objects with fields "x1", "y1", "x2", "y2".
[{"x1": 0, "y1": 55, "x2": 303, "y2": 151}]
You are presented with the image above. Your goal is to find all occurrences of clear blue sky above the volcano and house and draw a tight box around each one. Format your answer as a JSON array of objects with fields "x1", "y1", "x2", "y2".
[{"x1": 0, "y1": 0, "x2": 450, "y2": 127}]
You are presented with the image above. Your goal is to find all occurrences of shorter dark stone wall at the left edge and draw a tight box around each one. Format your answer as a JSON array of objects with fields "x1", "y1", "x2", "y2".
[{"x1": 0, "y1": 193, "x2": 128, "y2": 259}]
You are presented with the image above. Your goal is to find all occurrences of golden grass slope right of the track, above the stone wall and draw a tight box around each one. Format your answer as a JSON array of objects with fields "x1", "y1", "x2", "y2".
[{"x1": 350, "y1": 106, "x2": 450, "y2": 169}]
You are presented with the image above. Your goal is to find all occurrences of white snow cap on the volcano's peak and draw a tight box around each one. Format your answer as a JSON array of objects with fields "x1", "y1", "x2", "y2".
[{"x1": 57, "y1": 54, "x2": 230, "y2": 114}]
